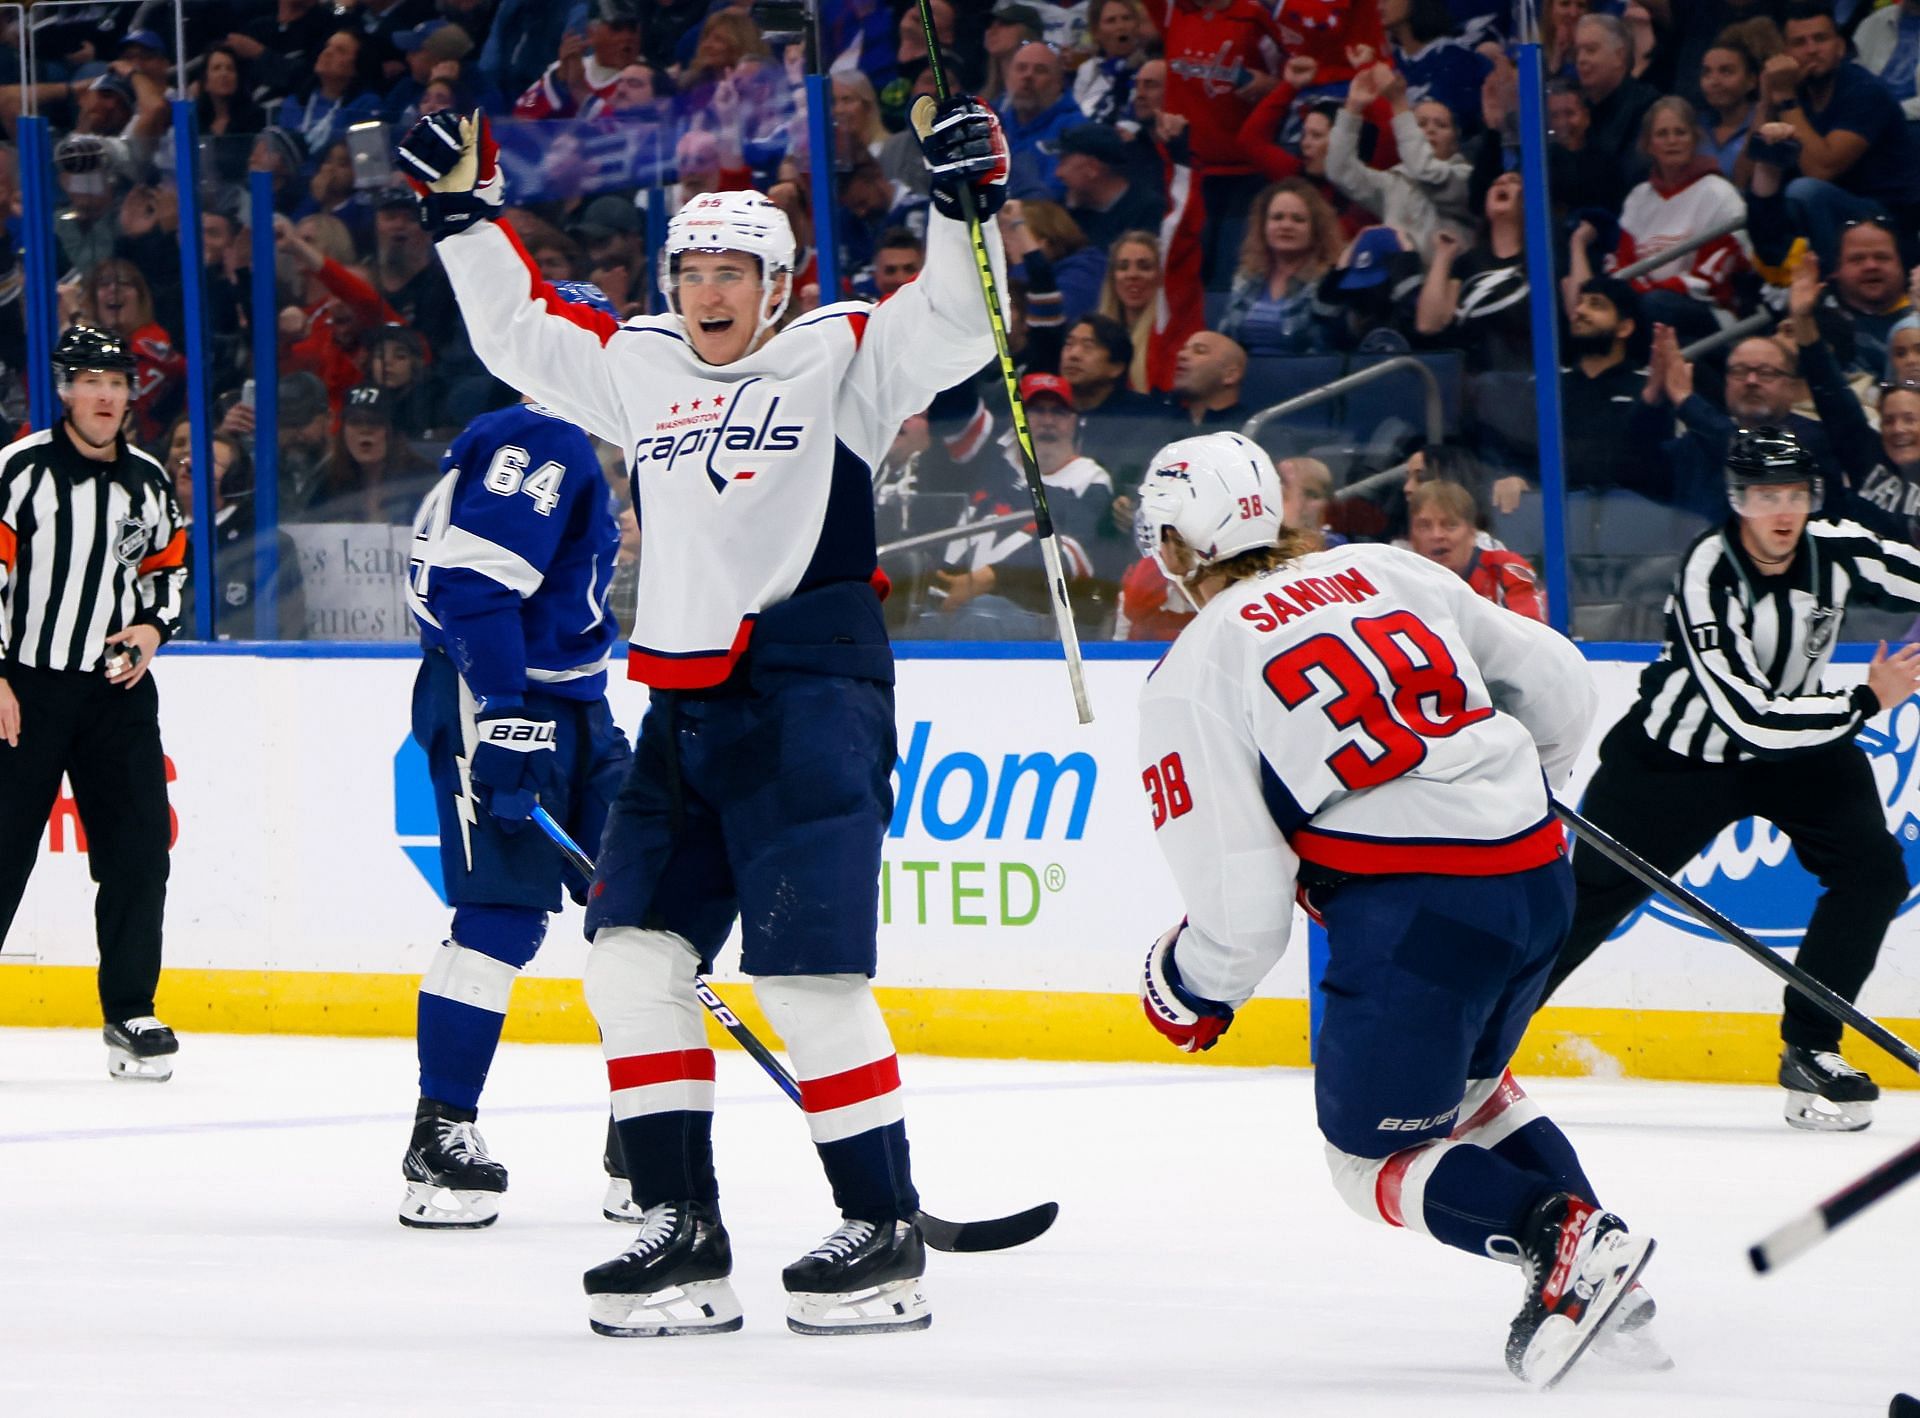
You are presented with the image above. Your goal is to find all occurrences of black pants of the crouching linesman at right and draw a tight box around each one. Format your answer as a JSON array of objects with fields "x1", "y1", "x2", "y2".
[{"x1": 1542, "y1": 720, "x2": 1907, "y2": 1050}]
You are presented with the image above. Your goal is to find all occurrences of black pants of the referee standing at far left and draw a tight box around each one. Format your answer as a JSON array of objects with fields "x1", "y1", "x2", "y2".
[{"x1": 0, "y1": 666, "x2": 169, "y2": 1021}]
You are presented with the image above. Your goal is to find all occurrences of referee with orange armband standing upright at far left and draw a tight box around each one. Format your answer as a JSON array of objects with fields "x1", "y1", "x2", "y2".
[{"x1": 0, "y1": 326, "x2": 186, "y2": 1080}]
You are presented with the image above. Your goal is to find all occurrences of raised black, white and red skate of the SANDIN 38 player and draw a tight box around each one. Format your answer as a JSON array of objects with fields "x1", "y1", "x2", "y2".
[{"x1": 1507, "y1": 1192, "x2": 1653, "y2": 1389}]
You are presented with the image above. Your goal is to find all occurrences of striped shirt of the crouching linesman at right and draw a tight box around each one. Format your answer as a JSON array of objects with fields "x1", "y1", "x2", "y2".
[{"x1": 1628, "y1": 520, "x2": 1920, "y2": 764}]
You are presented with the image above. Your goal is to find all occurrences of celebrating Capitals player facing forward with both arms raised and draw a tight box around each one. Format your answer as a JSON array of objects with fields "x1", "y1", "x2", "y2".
[{"x1": 401, "y1": 100, "x2": 1006, "y2": 1335}]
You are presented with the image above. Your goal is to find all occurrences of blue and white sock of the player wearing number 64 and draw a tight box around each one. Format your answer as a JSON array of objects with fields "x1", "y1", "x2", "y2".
[{"x1": 417, "y1": 908, "x2": 547, "y2": 1109}]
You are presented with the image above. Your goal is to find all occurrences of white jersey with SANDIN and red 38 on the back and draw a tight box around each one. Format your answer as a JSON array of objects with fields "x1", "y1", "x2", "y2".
[{"x1": 1140, "y1": 545, "x2": 1594, "y2": 1000}]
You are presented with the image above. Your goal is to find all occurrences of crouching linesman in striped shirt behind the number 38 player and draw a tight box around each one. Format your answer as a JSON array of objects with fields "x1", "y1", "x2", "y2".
[{"x1": 1542, "y1": 428, "x2": 1920, "y2": 1132}]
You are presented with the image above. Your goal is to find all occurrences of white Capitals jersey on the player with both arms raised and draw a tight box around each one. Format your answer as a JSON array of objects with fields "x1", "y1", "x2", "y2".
[{"x1": 436, "y1": 208, "x2": 1004, "y2": 689}]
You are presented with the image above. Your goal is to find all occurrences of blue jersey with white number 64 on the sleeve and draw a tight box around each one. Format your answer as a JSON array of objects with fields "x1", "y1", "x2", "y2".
[{"x1": 407, "y1": 405, "x2": 620, "y2": 704}]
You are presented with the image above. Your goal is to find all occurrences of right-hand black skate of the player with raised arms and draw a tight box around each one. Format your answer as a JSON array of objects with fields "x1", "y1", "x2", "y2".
[{"x1": 780, "y1": 1220, "x2": 933, "y2": 1334}]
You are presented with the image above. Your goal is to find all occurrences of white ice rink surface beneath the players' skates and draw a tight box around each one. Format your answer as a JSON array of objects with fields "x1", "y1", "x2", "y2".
[{"x1": 0, "y1": 1030, "x2": 1920, "y2": 1418}]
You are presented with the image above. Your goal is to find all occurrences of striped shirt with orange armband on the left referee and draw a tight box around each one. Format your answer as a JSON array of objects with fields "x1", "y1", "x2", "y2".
[{"x1": 0, "y1": 422, "x2": 186, "y2": 672}]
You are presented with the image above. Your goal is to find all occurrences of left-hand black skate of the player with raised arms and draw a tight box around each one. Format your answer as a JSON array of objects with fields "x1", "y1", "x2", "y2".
[{"x1": 586, "y1": 1201, "x2": 741, "y2": 1339}]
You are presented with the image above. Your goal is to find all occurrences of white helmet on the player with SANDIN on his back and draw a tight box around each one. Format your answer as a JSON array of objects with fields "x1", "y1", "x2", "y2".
[{"x1": 1135, "y1": 434, "x2": 1281, "y2": 585}]
